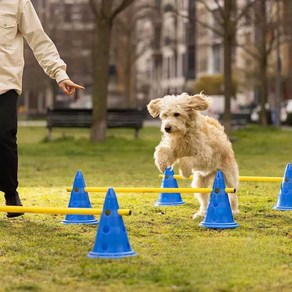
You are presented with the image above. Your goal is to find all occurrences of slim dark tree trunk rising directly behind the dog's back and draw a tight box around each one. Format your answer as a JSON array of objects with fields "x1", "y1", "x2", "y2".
[{"x1": 223, "y1": 0, "x2": 234, "y2": 135}]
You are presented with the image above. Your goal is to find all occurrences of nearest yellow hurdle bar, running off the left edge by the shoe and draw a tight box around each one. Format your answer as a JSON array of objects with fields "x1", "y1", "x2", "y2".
[{"x1": 0, "y1": 206, "x2": 131, "y2": 216}]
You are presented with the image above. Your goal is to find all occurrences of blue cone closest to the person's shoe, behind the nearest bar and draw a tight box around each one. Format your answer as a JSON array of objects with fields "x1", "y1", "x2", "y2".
[{"x1": 62, "y1": 171, "x2": 98, "y2": 224}]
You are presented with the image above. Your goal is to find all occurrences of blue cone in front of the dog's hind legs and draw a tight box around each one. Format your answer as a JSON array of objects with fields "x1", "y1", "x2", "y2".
[{"x1": 200, "y1": 170, "x2": 238, "y2": 229}]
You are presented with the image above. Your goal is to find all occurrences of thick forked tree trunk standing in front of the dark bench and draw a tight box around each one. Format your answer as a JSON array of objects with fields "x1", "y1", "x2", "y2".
[{"x1": 89, "y1": 0, "x2": 134, "y2": 142}]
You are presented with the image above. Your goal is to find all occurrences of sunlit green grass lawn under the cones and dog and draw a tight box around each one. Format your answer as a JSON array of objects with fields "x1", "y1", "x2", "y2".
[{"x1": 0, "y1": 127, "x2": 292, "y2": 291}]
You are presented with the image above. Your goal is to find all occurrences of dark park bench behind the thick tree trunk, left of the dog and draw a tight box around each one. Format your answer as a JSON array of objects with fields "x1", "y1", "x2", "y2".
[{"x1": 47, "y1": 108, "x2": 146, "y2": 141}]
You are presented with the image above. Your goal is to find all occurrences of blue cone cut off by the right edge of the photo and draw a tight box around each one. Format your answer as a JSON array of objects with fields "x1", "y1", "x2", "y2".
[{"x1": 273, "y1": 163, "x2": 292, "y2": 211}]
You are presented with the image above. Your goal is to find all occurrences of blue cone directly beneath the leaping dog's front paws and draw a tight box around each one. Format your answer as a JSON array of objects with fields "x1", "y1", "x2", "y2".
[{"x1": 154, "y1": 167, "x2": 185, "y2": 206}]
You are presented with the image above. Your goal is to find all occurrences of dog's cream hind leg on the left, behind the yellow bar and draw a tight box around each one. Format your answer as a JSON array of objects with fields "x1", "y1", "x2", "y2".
[{"x1": 192, "y1": 172, "x2": 215, "y2": 219}]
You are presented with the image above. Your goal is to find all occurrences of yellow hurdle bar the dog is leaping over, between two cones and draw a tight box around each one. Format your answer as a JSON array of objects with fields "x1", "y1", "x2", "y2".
[{"x1": 66, "y1": 187, "x2": 236, "y2": 193}]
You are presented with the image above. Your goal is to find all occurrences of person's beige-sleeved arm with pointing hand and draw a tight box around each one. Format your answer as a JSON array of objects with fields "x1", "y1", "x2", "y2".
[{"x1": 19, "y1": 0, "x2": 84, "y2": 94}]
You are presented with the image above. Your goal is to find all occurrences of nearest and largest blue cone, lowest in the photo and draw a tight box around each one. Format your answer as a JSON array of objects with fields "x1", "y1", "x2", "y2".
[{"x1": 87, "y1": 188, "x2": 136, "y2": 259}]
